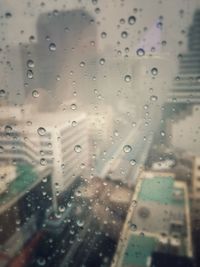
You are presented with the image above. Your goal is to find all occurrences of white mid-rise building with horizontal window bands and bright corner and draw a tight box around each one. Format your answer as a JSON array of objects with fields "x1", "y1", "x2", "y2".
[{"x1": 0, "y1": 111, "x2": 89, "y2": 197}]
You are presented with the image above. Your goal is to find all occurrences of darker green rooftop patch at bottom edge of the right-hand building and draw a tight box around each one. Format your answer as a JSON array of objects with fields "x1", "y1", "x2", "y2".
[{"x1": 122, "y1": 235, "x2": 157, "y2": 267}]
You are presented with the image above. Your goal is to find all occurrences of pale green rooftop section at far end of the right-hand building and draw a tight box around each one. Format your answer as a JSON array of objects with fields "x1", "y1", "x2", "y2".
[{"x1": 138, "y1": 176, "x2": 183, "y2": 205}]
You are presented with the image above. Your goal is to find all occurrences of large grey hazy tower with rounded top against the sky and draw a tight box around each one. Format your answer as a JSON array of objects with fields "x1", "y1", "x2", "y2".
[{"x1": 21, "y1": 9, "x2": 96, "y2": 110}]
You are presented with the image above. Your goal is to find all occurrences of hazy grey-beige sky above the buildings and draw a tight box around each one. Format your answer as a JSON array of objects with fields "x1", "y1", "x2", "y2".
[{"x1": 0, "y1": 0, "x2": 198, "y2": 59}]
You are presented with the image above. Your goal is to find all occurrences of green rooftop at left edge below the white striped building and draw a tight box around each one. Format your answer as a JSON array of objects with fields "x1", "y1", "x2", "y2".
[{"x1": 0, "y1": 164, "x2": 38, "y2": 205}]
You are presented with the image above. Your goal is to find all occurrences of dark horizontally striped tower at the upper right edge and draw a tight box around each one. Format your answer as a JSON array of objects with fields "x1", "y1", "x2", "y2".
[{"x1": 169, "y1": 10, "x2": 200, "y2": 104}]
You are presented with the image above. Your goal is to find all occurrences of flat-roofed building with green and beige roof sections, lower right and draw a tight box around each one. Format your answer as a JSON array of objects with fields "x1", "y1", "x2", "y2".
[{"x1": 112, "y1": 172, "x2": 193, "y2": 267}]
